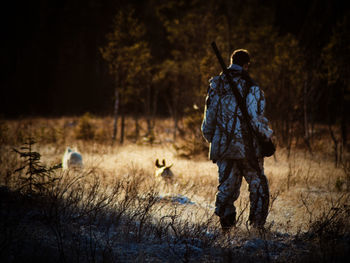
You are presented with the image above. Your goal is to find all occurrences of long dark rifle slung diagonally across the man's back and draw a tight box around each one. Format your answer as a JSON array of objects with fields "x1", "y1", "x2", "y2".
[{"x1": 211, "y1": 41, "x2": 276, "y2": 158}]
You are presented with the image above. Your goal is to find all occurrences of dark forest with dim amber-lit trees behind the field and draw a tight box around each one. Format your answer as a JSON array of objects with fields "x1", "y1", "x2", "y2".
[{"x1": 1, "y1": 0, "x2": 350, "y2": 143}]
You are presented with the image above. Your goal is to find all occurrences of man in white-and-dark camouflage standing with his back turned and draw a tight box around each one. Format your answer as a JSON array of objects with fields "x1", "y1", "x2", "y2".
[{"x1": 201, "y1": 49, "x2": 272, "y2": 231}]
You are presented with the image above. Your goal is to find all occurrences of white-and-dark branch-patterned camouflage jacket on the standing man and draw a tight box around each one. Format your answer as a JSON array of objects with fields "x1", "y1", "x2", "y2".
[{"x1": 201, "y1": 64, "x2": 272, "y2": 161}]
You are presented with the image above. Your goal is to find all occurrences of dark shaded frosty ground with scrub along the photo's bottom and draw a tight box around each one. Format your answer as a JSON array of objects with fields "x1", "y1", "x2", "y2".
[{"x1": 0, "y1": 184, "x2": 350, "y2": 262}]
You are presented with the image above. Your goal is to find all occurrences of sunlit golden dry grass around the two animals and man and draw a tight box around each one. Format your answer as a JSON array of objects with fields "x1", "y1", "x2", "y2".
[{"x1": 0, "y1": 116, "x2": 349, "y2": 261}]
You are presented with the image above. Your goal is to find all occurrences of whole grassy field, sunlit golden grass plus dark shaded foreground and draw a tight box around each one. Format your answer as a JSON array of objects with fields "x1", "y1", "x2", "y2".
[{"x1": 0, "y1": 115, "x2": 350, "y2": 262}]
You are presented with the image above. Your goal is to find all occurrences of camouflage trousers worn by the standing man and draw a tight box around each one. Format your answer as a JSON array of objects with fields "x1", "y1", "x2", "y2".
[{"x1": 215, "y1": 159, "x2": 269, "y2": 227}]
